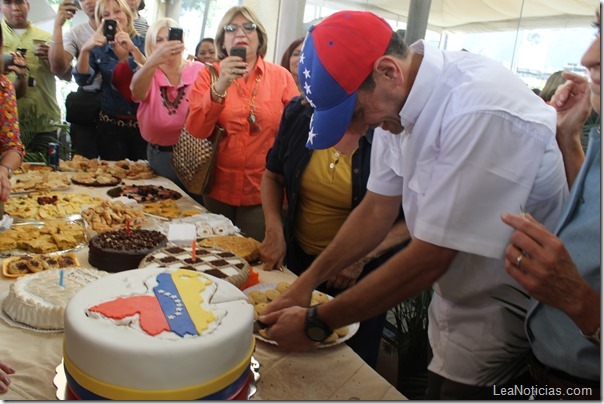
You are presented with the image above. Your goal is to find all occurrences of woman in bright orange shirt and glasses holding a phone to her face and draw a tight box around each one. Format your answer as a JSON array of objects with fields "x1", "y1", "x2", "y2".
[{"x1": 186, "y1": 6, "x2": 299, "y2": 241}]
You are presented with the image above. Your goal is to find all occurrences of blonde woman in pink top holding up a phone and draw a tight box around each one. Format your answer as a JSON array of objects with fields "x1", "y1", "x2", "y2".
[{"x1": 130, "y1": 18, "x2": 205, "y2": 196}]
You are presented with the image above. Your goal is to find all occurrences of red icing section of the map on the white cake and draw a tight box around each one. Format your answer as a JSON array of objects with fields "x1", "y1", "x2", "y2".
[{"x1": 89, "y1": 295, "x2": 170, "y2": 335}]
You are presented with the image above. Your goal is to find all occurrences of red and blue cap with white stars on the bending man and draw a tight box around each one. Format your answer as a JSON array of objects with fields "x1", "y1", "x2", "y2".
[{"x1": 298, "y1": 10, "x2": 393, "y2": 149}]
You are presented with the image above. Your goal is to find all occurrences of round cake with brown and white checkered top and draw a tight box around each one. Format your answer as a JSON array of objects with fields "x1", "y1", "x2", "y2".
[{"x1": 139, "y1": 246, "x2": 250, "y2": 288}]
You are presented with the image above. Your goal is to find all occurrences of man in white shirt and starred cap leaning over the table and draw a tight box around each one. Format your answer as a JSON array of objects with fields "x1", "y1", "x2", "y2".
[{"x1": 260, "y1": 11, "x2": 568, "y2": 399}]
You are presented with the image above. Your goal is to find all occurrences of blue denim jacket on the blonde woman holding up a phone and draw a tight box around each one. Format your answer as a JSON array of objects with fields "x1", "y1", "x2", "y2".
[{"x1": 73, "y1": 35, "x2": 145, "y2": 117}]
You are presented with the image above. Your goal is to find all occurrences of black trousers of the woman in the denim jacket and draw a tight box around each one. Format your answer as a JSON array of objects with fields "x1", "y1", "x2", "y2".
[{"x1": 98, "y1": 117, "x2": 147, "y2": 161}]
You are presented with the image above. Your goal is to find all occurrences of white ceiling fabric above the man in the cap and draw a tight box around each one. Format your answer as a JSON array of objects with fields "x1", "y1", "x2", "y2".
[{"x1": 323, "y1": 0, "x2": 599, "y2": 32}]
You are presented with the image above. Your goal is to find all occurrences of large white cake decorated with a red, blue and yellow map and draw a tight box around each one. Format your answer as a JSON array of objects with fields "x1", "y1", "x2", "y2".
[{"x1": 64, "y1": 266, "x2": 254, "y2": 400}]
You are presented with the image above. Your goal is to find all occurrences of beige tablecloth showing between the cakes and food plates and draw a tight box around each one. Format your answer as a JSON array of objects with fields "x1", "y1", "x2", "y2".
[{"x1": 0, "y1": 177, "x2": 405, "y2": 401}]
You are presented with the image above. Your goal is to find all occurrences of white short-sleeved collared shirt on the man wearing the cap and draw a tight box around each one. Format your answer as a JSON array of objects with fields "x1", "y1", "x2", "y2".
[{"x1": 367, "y1": 41, "x2": 568, "y2": 386}]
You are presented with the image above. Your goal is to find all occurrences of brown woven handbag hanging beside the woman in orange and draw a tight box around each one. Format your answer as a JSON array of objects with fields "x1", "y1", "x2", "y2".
[{"x1": 170, "y1": 64, "x2": 224, "y2": 195}]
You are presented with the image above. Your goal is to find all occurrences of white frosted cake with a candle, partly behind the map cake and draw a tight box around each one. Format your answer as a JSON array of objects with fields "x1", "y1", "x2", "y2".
[{"x1": 2, "y1": 268, "x2": 107, "y2": 330}]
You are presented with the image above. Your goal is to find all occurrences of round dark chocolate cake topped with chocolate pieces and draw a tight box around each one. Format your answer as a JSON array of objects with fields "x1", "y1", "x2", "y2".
[{"x1": 88, "y1": 229, "x2": 168, "y2": 272}]
